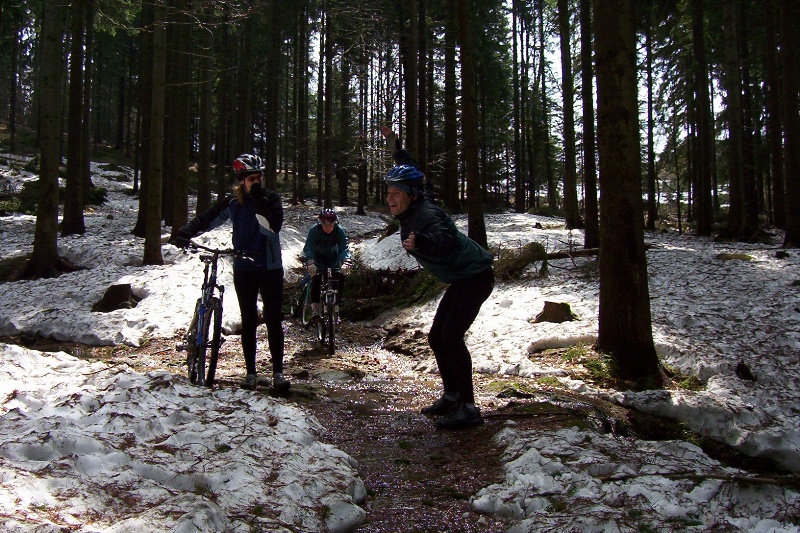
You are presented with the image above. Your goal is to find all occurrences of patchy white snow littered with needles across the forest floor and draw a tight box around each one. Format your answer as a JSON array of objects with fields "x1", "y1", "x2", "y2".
[{"x1": 0, "y1": 156, "x2": 800, "y2": 532}]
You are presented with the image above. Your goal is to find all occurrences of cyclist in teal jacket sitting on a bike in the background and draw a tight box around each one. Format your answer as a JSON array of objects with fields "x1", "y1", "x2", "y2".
[{"x1": 303, "y1": 208, "x2": 350, "y2": 317}]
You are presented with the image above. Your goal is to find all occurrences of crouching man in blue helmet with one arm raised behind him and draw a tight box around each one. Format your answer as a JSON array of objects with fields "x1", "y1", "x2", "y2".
[{"x1": 381, "y1": 126, "x2": 494, "y2": 429}]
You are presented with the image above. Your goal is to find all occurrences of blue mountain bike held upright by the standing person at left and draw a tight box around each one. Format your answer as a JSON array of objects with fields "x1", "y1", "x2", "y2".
[{"x1": 178, "y1": 241, "x2": 245, "y2": 387}]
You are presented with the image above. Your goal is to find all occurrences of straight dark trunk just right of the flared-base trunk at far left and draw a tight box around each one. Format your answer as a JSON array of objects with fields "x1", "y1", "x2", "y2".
[{"x1": 61, "y1": 0, "x2": 86, "y2": 236}]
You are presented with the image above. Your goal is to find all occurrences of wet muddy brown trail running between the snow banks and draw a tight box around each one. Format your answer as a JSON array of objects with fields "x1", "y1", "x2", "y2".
[{"x1": 0, "y1": 314, "x2": 776, "y2": 533}]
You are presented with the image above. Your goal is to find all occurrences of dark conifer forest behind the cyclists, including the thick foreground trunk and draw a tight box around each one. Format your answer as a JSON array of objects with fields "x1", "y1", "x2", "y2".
[{"x1": 0, "y1": 0, "x2": 800, "y2": 377}]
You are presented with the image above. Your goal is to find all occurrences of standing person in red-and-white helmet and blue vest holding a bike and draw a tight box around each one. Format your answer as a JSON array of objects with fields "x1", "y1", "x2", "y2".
[{"x1": 173, "y1": 154, "x2": 291, "y2": 391}]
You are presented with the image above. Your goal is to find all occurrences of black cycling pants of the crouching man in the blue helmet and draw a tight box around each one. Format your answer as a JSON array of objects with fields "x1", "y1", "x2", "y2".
[{"x1": 428, "y1": 268, "x2": 494, "y2": 403}]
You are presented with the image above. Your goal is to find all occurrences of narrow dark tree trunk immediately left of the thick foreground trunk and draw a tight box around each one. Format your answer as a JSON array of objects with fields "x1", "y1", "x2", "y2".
[{"x1": 580, "y1": 0, "x2": 600, "y2": 248}]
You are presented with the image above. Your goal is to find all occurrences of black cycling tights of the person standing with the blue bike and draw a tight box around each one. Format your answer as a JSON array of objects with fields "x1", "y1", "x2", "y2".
[{"x1": 233, "y1": 268, "x2": 283, "y2": 374}]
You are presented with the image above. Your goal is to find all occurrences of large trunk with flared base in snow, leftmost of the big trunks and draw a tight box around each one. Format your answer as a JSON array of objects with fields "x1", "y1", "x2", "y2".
[{"x1": 24, "y1": 0, "x2": 67, "y2": 278}]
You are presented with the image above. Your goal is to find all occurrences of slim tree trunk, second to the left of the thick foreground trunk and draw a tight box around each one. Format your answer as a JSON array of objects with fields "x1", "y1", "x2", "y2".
[{"x1": 558, "y1": 0, "x2": 583, "y2": 229}]
